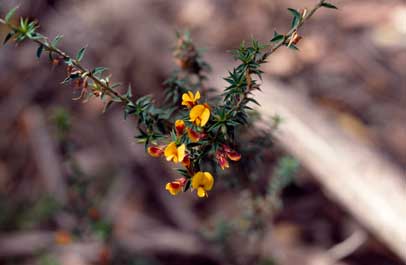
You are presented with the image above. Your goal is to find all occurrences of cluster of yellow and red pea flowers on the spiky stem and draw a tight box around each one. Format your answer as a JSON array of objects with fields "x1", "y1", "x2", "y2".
[{"x1": 147, "y1": 91, "x2": 241, "y2": 197}]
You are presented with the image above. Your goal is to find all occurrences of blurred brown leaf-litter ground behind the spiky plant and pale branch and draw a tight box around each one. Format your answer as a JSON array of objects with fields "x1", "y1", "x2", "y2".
[{"x1": 0, "y1": 0, "x2": 406, "y2": 265}]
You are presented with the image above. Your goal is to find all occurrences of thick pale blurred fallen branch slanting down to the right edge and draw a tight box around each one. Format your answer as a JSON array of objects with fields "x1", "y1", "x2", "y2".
[{"x1": 209, "y1": 56, "x2": 406, "y2": 261}]
